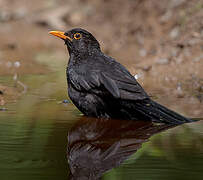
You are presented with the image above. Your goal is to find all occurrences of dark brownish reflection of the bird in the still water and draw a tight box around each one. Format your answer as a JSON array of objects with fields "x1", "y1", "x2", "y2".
[{"x1": 67, "y1": 117, "x2": 175, "y2": 180}]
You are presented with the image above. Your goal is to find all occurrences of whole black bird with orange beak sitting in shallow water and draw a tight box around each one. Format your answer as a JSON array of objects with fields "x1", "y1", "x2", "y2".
[{"x1": 50, "y1": 28, "x2": 192, "y2": 124}]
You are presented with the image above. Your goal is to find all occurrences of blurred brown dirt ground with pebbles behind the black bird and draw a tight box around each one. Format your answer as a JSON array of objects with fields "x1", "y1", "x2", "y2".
[{"x1": 0, "y1": 0, "x2": 203, "y2": 117}]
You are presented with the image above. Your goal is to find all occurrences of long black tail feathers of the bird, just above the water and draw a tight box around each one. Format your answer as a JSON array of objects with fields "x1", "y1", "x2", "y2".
[{"x1": 136, "y1": 100, "x2": 195, "y2": 124}]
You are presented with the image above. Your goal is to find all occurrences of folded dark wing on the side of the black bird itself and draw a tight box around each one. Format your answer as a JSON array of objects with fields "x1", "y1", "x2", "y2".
[{"x1": 69, "y1": 57, "x2": 149, "y2": 100}]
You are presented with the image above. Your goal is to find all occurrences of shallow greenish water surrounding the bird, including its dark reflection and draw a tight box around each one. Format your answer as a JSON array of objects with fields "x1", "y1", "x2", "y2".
[{"x1": 0, "y1": 74, "x2": 203, "y2": 180}]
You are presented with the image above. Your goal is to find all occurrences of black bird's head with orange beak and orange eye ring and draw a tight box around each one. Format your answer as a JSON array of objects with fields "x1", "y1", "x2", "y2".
[{"x1": 49, "y1": 28, "x2": 100, "y2": 55}]
